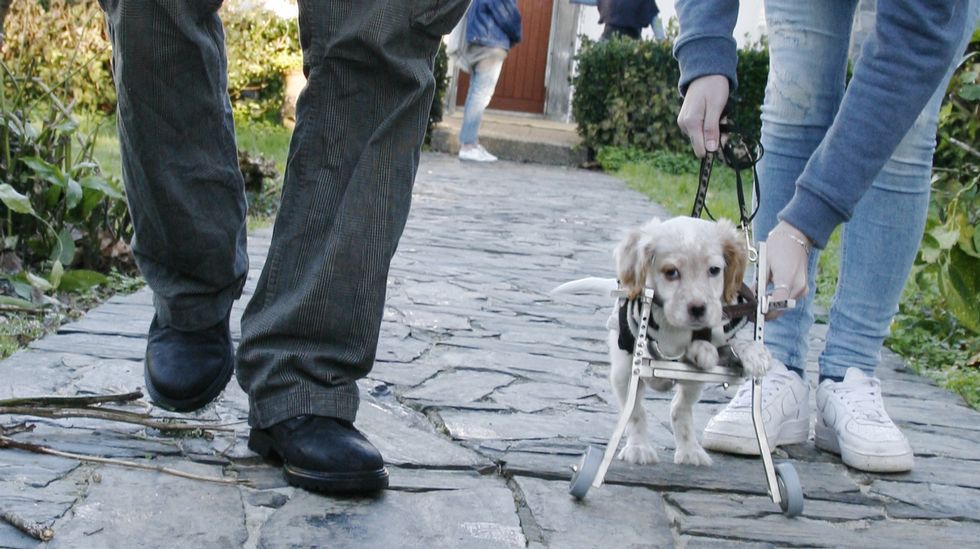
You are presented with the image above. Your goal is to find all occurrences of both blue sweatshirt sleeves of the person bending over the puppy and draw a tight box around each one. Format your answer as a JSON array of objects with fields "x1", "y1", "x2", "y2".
[{"x1": 674, "y1": 0, "x2": 976, "y2": 248}]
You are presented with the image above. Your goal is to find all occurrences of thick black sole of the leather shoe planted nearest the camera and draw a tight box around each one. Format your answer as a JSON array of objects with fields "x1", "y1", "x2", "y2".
[{"x1": 248, "y1": 429, "x2": 388, "y2": 495}]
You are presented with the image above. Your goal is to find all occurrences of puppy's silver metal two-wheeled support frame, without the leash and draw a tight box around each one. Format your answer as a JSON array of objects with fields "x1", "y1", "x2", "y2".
[{"x1": 569, "y1": 242, "x2": 803, "y2": 517}]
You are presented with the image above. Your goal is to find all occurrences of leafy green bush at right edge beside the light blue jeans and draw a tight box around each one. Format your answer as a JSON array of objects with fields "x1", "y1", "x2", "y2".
[{"x1": 887, "y1": 31, "x2": 980, "y2": 408}]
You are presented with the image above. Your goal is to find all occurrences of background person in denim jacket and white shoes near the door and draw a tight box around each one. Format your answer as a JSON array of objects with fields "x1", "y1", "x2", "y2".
[{"x1": 457, "y1": 0, "x2": 521, "y2": 162}]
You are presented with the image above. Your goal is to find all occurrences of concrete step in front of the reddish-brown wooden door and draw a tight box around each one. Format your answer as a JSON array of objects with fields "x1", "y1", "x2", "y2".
[{"x1": 431, "y1": 111, "x2": 588, "y2": 166}]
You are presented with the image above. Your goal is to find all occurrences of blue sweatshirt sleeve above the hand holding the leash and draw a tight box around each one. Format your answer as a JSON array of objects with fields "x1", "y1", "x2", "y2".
[{"x1": 674, "y1": 0, "x2": 738, "y2": 95}]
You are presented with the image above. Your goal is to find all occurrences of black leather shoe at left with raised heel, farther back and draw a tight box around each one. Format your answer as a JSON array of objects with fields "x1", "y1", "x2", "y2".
[{"x1": 143, "y1": 316, "x2": 235, "y2": 412}]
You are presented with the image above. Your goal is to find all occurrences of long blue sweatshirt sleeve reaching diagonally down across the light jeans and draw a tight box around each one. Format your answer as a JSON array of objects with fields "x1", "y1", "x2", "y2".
[{"x1": 779, "y1": 0, "x2": 975, "y2": 247}]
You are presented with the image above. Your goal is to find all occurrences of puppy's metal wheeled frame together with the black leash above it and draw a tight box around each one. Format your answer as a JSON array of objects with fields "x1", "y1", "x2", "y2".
[{"x1": 569, "y1": 132, "x2": 803, "y2": 517}]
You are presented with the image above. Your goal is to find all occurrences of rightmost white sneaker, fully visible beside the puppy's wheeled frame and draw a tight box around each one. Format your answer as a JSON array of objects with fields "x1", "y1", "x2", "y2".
[{"x1": 814, "y1": 368, "x2": 912, "y2": 473}]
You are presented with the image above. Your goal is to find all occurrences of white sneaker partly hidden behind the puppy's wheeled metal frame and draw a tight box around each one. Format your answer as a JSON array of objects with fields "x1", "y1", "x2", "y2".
[{"x1": 701, "y1": 360, "x2": 810, "y2": 456}]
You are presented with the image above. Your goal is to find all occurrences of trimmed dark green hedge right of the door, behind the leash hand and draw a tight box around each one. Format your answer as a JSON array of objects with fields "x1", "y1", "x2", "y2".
[{"x1": 572, "y1": 38, "x2": 769, "y2": 152}]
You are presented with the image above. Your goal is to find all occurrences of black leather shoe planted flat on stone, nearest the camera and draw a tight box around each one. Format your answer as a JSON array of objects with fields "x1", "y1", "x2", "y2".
[{"x1": 248, "y1": 416, "x2": 388, "y2": 494}]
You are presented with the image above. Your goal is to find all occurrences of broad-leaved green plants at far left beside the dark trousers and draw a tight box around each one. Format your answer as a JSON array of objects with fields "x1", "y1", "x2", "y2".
[{"x1": 0, "y1": 64, "x2": 132, "y2": 306}]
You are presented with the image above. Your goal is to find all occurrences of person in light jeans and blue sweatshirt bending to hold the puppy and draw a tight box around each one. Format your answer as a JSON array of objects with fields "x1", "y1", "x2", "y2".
[{"x1": 674, "y1": 0, "x2": 980, "y2": 472}]
